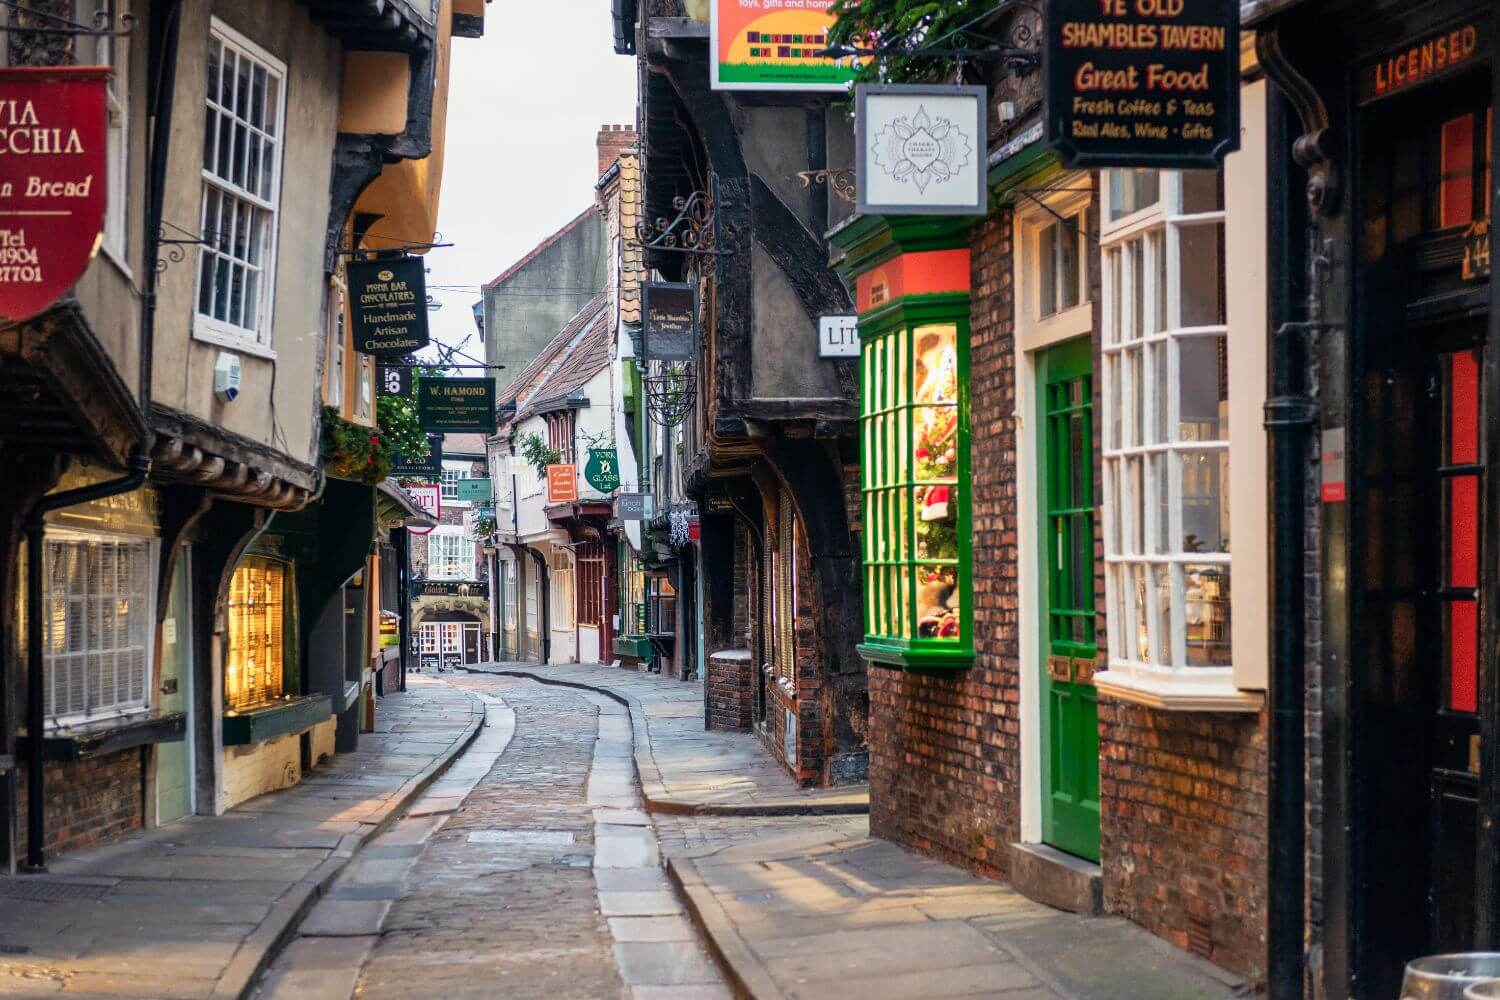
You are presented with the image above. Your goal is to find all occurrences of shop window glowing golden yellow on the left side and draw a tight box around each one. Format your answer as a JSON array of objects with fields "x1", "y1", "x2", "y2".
[{"x1": 224, "y1": 556, "x2": 288, "y2": 712}]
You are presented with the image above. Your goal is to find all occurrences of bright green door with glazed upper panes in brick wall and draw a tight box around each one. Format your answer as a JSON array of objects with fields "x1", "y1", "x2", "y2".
[{"x1": 1037, "y1": 337, "x2": 1100, "y2": 861}]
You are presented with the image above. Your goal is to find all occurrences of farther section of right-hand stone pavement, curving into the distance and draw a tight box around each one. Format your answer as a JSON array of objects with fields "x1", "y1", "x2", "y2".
[{"x1": 467, "y1": 663, "x2": 870, "y2": 816}]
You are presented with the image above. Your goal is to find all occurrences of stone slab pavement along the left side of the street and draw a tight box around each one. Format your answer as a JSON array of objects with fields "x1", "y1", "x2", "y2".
[{"x1": 0, "y1": 676, "x2": 485, "y2": 999}]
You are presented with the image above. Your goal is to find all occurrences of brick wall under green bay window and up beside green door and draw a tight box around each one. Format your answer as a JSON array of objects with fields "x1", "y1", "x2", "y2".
[{"x1": 869, "y1": 211, "x2": 1020, "y2": 877}]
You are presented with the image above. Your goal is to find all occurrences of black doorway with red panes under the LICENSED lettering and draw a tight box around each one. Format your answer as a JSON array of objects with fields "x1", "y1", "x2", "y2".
[{"x1": 1356, "y1": 72, "x2": 1493, "y2": 996}]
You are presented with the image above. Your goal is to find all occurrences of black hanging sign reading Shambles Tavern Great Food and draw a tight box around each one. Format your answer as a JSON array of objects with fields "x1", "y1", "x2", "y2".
[{"x1": 1044, "y1": 0, "x2": 1241, "y2": 169}]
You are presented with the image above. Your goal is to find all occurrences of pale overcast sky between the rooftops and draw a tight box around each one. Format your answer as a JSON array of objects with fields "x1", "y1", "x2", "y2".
[{"x1": 428, "y1": 0, "x2": 636, "y2": 359}]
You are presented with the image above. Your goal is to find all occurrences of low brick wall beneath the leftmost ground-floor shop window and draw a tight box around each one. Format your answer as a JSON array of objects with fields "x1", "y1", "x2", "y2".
[{"x1": 17, "y1": 748, "x2": 146, "y2": 853}]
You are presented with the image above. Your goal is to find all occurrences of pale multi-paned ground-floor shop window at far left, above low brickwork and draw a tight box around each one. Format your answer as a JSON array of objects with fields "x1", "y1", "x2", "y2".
[{"x1": 42, "y1": 531, "x2": 158, "y2": 727}]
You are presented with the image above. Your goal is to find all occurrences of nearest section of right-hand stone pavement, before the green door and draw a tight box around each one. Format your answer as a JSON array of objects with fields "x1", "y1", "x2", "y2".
[{"x1": 662, "y1": 817, "x2": 1251, "y2": 1000}]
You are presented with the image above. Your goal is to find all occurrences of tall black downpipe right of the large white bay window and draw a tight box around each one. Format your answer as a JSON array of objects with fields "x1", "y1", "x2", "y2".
[{"x1": 1265, "y1": 90, "x2": 1322, "y2": 1000}]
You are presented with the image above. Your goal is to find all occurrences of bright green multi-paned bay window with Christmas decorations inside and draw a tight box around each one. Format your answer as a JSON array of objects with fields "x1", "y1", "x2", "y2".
[{"x1": 860, "y1": 294, "x2": 974, "y2": 670}]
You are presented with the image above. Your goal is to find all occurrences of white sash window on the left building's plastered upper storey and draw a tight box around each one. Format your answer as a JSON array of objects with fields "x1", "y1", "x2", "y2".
[{"x1": 194, "y1": 19, "x2": 287, "y2": 354}]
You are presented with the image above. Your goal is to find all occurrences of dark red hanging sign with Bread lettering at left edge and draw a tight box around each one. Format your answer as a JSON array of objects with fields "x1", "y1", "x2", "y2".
[{"x1": 0, "y1": 66, "x2": 110, "y2": 321}]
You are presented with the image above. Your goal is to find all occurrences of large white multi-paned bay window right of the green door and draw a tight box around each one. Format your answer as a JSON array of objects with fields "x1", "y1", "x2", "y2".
[{"x1": 1095, "y1": 97, "x2": 1266, "y2": 711}]
